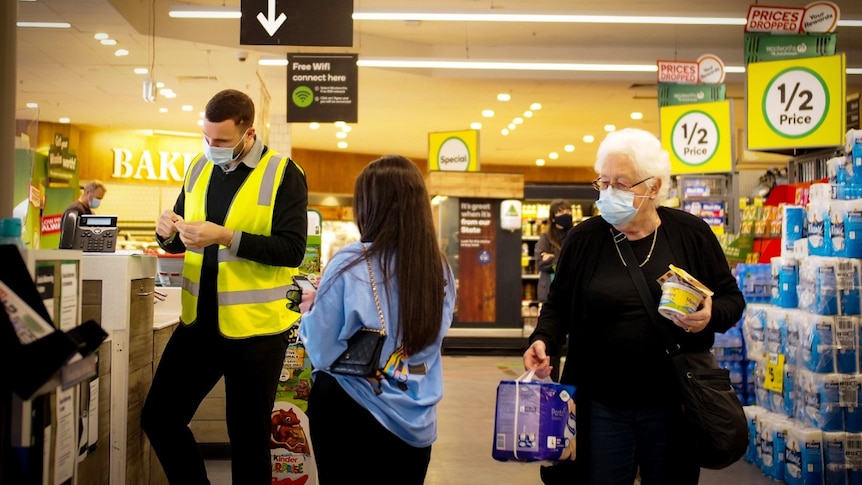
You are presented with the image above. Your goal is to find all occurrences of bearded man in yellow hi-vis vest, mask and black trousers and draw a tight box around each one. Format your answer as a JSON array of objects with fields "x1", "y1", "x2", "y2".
[{"x1": 141, "y1": 89, "x2": 308, "y2": 485}]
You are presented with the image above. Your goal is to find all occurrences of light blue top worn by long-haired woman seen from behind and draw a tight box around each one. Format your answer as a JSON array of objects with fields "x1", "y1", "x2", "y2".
[{"x1": 299, "y1": 242, "x2": 455, "y2": 447}]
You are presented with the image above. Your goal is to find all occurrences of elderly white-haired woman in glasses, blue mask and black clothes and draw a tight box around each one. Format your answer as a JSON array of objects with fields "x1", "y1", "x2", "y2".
[{"x1": 524, "y1": 128, "x2": 745, "y2": 485}]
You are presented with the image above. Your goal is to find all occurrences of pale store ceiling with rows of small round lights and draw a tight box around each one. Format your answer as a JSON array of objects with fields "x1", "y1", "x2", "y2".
[{"x1": 11, "y1": 0, "x2": 862, "y2": 167}]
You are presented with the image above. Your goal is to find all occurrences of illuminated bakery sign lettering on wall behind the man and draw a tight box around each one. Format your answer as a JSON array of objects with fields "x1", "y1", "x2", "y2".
[{"x1": 111, "y1": 148, "x2": 197, "y2": 182}]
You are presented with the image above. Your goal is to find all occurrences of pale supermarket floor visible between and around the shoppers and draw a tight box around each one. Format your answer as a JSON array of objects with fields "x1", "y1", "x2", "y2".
[{"x1": 207, "y1": 356, "x2": 777, "y2": 485}]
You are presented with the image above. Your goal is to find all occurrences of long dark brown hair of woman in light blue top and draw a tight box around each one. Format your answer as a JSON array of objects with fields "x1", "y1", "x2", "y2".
[{"x1": 353, "y1": 155, "x2": 446, "y2": 355}]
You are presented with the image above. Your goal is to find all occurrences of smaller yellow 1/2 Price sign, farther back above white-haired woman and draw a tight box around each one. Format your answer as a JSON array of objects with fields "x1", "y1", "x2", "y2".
[{"x1": 661, "y1": 101, "x2": 733, "y2": 175}]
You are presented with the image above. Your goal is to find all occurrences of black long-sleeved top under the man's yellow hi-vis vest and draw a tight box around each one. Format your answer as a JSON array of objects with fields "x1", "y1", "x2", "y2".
[{"x1": 156, "y1": 147, "x2": 308, "y2": 321}]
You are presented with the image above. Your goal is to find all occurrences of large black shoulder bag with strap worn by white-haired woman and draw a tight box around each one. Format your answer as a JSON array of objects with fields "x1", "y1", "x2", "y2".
[{"x1": 611, "y1": 229, "x2": 748, "y2": 470}]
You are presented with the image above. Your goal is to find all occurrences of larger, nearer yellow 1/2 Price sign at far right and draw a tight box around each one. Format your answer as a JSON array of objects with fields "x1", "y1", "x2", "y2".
[{"x1": 746, "y1": 54, "x2": 846, "y2": 150}]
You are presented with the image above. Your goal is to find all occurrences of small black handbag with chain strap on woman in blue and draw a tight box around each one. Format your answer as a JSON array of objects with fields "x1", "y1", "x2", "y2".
[{"x1": 329, "y1": 243, "x2": 386, "y2": 377}]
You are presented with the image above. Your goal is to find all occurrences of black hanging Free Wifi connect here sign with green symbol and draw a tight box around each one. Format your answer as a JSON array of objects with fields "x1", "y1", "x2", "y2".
[{"x1": 287, "y1": 54, "x2": 359, "y2": 123}]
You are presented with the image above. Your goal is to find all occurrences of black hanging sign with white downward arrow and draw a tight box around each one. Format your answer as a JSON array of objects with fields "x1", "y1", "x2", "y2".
[{"x1": 239, "y1": 0, "x2": 353, "y2": 47}]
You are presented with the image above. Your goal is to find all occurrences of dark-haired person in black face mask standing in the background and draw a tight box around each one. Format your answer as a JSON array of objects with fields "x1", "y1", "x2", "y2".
[{"x1": 534, "y1": 199, "x2": 573, "y2": 381}]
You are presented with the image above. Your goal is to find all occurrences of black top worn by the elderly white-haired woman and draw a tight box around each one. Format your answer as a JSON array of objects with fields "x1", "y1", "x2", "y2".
[{"x1": 530, "y1": 207, "x2": 745, "y2": 409}]
